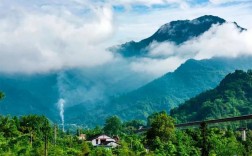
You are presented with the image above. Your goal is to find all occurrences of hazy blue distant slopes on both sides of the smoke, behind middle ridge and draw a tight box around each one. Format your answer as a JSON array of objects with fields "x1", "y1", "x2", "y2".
[{"x1": 0, "y1": 67, "x2": 150, "y2": 123}]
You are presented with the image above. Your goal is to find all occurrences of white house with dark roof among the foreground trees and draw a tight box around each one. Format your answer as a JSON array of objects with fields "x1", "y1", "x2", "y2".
[{"x1": 91, "y1": 134, "x2": 119, "y2": 148}]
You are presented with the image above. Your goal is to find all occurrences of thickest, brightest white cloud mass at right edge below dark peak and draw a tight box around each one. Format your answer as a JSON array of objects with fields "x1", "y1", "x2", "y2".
[{"x1": 185, "y1": 24, "x2": 252, "y2": 59}]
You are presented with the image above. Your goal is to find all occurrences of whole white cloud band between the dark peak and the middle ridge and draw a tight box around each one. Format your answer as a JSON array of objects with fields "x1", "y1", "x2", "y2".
[{"x1": 132, "y1": 23, "x2": 252, "y2": 76}]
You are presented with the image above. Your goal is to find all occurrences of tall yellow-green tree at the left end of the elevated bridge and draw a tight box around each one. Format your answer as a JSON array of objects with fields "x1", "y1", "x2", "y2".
[{"x1": 146, "y1": 112, "x2": 175, "y2": 150}]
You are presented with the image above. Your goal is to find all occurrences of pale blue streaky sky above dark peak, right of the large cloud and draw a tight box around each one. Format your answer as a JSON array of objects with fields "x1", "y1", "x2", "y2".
[{"x1": 110, "y1": 0, "x2": 252, "y2": 42}]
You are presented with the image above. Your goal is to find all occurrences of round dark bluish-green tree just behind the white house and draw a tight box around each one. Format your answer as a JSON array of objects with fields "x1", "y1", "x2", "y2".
[{"x1": 103, "y1": 116, "x2": 122, "y2": 135}]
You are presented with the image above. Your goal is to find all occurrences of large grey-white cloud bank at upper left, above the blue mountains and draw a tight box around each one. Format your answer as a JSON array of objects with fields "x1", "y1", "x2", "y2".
[{"x1": 0, "y1": 2, "x2": 113, "y2": 73}]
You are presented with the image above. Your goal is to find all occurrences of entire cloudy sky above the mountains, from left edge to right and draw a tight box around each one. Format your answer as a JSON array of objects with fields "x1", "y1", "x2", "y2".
[{"x1": 0, "y1": 0, "x2": 252, "y2": 74}]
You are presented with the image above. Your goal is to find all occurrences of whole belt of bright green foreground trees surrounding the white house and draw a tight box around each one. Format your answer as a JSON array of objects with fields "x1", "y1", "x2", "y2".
[{"x1": 0, "y1": 112, "x2": 252, "y2": 156}]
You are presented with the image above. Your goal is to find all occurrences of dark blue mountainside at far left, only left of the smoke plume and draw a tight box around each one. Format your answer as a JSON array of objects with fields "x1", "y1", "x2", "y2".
[{"x1": 0, "y1": 74, "x2": 59, "y2": 119}]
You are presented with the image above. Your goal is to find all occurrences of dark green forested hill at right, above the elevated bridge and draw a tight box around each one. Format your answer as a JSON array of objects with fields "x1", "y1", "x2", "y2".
[{"x1": 171, "y1": 70, "x2": 252, "y2": 122}]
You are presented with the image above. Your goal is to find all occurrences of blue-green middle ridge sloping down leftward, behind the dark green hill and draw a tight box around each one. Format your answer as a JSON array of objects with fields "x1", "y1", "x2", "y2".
[{"x1": 64, "y1": 56, "x2": 252, "y2": 123}]
